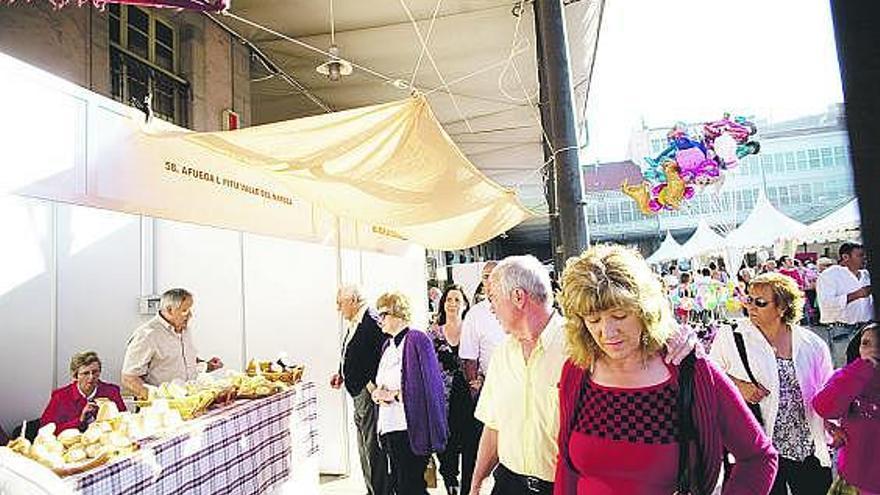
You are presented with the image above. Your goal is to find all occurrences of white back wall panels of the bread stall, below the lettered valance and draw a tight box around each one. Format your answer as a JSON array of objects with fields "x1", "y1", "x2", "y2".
[{"x1": 0, "y1": 196, "x2": 427, "y2": 473}]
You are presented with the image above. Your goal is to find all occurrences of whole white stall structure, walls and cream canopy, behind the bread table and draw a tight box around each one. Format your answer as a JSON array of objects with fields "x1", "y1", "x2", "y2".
[{"x1": 0, "y1": 50, "x2": 530, "y2": 493}]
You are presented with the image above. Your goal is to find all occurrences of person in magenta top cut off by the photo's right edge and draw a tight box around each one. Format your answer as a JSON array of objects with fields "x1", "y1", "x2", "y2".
[{"x1": 813, "y1": 323, "x2": 880, "y2": 495}]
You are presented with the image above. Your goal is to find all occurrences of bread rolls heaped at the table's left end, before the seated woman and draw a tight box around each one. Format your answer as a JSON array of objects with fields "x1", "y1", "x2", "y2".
[{"x1": 7, "y1": 399, "x2": 138, "y2": 476}]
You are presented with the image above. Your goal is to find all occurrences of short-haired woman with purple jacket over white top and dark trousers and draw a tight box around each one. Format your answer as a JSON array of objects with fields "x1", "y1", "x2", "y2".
[{"x1": 372, "y1": 292, "x2": 448, "y2": 495}]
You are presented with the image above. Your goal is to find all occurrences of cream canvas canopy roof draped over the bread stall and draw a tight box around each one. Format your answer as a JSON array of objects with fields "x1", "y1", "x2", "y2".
[{"x1": 152, "y1": 96, "x2": 532, "y2": 250}]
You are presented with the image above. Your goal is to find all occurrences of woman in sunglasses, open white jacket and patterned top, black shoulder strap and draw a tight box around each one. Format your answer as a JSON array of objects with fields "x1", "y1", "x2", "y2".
[{"x1": 711, "y1": 272, "x2": 833, "y2": 495}]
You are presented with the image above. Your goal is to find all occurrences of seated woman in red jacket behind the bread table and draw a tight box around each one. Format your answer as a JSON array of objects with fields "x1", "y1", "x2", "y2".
[{"x1": 40, "y1": 351, "x2": 125, "y2": 431}]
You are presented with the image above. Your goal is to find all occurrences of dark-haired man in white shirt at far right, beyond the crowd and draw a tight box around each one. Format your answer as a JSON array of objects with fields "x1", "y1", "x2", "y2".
[{"x1": 816, "y1": 242, "x2": 874, "y2": 340}]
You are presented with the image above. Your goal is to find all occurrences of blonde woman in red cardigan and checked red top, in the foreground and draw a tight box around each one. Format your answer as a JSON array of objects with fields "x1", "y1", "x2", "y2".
[{"x1": 554, "y1": 245, "x2": 777, "y2": 495}]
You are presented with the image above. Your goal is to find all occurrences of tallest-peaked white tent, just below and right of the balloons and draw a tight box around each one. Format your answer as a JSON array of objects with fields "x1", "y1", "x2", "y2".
[{"x1": 726, "y1": 192, "x2": 806, "y2": 249}]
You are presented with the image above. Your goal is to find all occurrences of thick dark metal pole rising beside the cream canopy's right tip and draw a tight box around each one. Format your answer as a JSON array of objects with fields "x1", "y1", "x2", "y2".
[{"x1": 534, "y1": 0, "x2": 587, "y2": 259}]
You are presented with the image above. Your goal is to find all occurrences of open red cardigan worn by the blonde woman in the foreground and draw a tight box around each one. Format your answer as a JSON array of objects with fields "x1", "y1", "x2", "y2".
[{"x1": 553, "y1": 358, "x2": 778, "y2": 495}]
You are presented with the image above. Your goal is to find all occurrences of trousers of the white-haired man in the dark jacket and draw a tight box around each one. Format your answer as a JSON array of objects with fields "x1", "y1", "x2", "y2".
[{"x1": 354, "y1": 388, "x2": 390, "y2": 495}]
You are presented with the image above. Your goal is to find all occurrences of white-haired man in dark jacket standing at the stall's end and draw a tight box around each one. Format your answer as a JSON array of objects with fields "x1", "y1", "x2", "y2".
[{"x1": 330, "y1": 286, "x2": 390, "y2": 495}]
